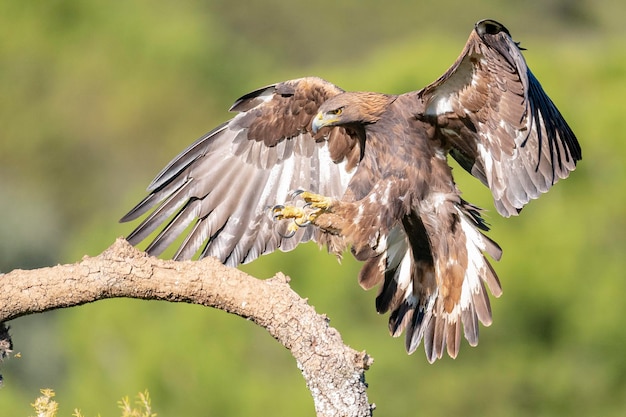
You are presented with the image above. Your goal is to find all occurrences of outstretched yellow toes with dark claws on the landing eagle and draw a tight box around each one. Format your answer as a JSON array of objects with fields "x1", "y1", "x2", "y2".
[{"x1": 272, "y1": 190, "x2": 333, "y2": 237}]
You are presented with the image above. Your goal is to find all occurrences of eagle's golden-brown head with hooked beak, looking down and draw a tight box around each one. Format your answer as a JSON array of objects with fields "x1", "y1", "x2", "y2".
[{"x1": 311, "y1": 92, "x2": 395, "y2": 133}]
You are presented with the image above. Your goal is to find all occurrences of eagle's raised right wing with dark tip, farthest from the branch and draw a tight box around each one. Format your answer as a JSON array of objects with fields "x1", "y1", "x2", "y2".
[{"x1": 420, "y1": 20, "x2": 582, "y2": 217}]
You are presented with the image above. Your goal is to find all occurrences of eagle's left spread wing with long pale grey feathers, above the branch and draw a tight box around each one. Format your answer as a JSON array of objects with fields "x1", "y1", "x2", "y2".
[{"x1": 120, "y1": 77, "x2": 360, "y2": 266}]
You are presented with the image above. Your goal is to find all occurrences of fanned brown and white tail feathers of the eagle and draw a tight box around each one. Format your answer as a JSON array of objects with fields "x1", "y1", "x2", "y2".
[{"x1": 359, "y1": 200, "x2": 502, "y2": 363}]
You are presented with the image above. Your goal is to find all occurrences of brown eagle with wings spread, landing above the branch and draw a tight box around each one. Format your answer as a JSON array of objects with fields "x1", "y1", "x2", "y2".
[{"x1": 120, "y1": 20, "x2": 582, "y2": 363}]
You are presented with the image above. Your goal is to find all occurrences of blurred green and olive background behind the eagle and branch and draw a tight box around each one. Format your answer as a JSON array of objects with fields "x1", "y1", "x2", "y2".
[{"x1": 0, "y1": 0, "x2": 626, "y2": 417}]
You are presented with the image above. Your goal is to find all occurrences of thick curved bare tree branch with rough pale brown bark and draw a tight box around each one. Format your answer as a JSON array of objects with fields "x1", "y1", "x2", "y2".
[{"x1": 0, "y1": 239, "x2": 374, "y2": 417}]
